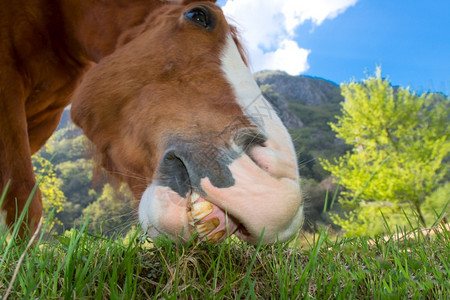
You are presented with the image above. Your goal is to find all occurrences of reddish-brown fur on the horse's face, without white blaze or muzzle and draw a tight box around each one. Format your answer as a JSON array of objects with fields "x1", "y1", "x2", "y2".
[{"x1": 72, "y1": 1, "x2": 249, "y2": 199}]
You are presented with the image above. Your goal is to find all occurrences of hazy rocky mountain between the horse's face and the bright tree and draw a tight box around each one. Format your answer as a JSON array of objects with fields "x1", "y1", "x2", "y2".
[{"x1": 255, "y1": 71, "x2": 348, "y2": 182}]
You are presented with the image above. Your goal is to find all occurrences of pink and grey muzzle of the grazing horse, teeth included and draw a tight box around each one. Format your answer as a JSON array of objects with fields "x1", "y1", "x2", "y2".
[{"x1": 139, "y1": 128, "x2": 303, "y2": 244}]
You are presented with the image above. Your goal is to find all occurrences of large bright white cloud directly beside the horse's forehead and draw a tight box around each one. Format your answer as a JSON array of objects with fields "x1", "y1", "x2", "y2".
[{"x1": 223, "y1": 0, "x2": 357, "y2": 75}]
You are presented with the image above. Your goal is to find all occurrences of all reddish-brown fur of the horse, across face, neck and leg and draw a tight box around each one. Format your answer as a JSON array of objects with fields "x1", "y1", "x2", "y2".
[{"x1": 0, "y1": 0, "x2": 250, "y2": 235}]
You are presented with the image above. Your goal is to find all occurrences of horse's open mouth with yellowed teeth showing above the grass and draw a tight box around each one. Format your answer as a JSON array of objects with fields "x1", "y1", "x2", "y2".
[{"x1": 187, "y1": 191, "x2": 250, "y2": 242}]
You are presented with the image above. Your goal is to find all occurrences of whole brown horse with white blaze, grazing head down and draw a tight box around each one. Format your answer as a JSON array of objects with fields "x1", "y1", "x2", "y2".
[{"x1": 0, "y1": 0, "x2": 303, "y2": 243}]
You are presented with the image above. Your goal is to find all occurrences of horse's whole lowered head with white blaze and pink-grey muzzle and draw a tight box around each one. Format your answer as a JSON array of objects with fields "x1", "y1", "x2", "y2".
[{"x1": 72, "y1": 1, "x2": 303, "y2": 243}]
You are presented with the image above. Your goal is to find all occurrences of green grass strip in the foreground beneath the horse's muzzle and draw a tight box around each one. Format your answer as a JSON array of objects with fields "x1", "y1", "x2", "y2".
[{"x1": 0, "y1": 214, "x2": 450, "y2": 299}]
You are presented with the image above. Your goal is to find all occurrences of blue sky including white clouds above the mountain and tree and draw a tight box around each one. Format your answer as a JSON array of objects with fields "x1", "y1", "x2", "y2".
[{"x1": 218, "y1": 0, "x2": 450, "y2": 95}]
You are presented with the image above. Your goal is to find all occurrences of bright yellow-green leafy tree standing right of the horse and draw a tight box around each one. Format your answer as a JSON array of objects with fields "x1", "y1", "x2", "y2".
[{"x1": 321, "y1": 68, "x2": 450, "y2": 234}]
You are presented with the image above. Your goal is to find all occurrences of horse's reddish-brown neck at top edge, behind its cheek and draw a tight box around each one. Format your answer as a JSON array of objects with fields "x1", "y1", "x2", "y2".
[{"x1": 59, "y1": 0, "x2": 166, "y2": 62}]
